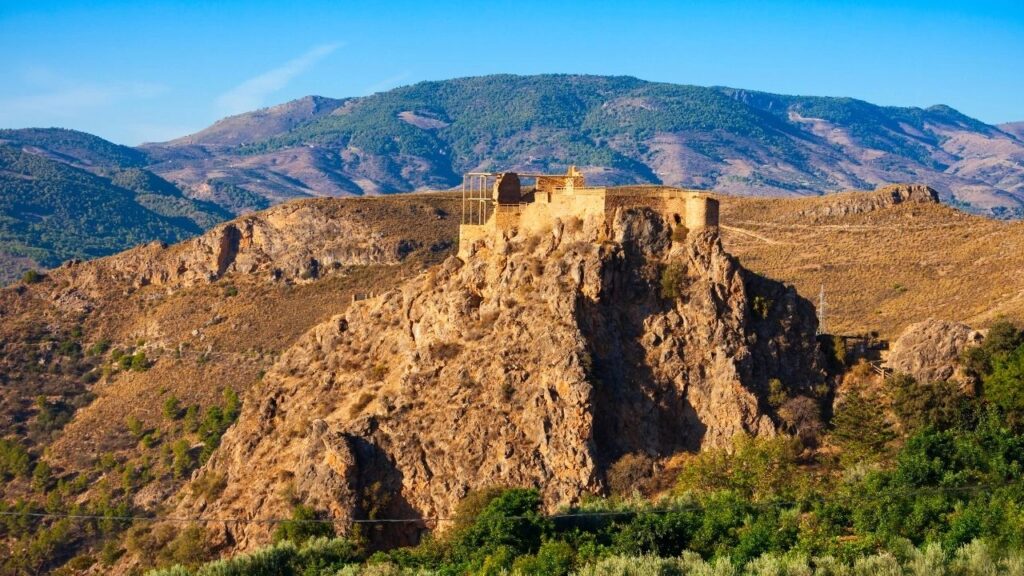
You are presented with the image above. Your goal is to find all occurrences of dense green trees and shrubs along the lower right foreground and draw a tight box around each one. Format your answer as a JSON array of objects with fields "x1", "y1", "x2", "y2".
[{"x1": 146, "y1": 323, "x2": 1024, "y2": 576}]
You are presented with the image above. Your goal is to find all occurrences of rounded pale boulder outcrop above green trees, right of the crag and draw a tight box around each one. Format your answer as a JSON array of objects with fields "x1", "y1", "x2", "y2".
[{"x1": 887, "y1": 319, "x2": 982, "y2": 382}]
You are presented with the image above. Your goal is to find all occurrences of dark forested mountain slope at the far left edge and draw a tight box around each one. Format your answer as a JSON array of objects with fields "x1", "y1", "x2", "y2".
[{"x1": 0, "y1": 129, "x2": 230, "y2": 283}]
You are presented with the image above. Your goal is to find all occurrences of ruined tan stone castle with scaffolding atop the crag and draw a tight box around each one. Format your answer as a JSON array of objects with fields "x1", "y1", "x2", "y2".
[{"x1": 459, "y1": 166, "x2": 718, "y2": 258}]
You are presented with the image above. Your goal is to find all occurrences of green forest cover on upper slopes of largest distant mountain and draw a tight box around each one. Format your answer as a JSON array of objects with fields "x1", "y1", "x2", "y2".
[{"x1": 232, "y1": 75, "x2": 991, "y2": 186}]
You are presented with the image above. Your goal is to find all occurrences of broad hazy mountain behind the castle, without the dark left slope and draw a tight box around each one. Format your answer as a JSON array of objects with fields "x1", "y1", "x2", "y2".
[{"x1": 144, "y1": 75, "x2": 1024, "y2": 215}]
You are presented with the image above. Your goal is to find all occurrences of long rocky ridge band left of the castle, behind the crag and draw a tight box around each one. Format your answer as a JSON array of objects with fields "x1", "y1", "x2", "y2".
[{"x1": 44, "y1": 199, "x2": 455, "y2": 297}]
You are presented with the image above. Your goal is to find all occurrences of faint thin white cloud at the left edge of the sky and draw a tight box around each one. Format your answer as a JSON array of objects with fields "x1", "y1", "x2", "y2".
[{"x1": 0, "y1": 82, "x2": 167, "y2": 119}]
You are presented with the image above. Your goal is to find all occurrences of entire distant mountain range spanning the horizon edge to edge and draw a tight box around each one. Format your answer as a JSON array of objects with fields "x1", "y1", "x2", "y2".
[{"x1": 0, "y1": 75, "x2": 1024, "y2": 280}]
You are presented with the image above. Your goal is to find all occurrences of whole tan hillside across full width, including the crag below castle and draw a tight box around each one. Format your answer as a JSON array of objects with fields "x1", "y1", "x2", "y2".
[{"x1": 0, "y1": 187, "x2": 1024, "y2": 573}]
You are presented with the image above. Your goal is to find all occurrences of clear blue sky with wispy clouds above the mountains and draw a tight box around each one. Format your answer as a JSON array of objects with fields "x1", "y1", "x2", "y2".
[{"x1": 0, "y1": 0, "x2": 1024, "y2": 145}]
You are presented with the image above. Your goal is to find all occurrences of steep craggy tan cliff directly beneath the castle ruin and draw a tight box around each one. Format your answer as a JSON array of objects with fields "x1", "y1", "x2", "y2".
[{"x1": 178, "y1": 206, "x2": 822, "y2": 549}]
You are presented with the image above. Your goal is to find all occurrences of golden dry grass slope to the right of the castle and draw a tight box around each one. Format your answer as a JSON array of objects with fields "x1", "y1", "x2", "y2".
[{"x1": 720, "y1": 196, "x2": 1024, "y2": 337}]
